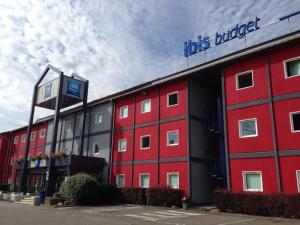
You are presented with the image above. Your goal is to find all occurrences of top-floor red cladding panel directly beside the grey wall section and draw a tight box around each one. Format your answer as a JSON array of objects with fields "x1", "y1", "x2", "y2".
[{"x1": 114, "y1": 96, "x2": 134, "y2": 128}]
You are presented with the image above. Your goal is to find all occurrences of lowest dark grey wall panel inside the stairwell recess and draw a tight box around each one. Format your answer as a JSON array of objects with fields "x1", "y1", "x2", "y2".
[{"x1": 191, "y1": 162, "x2": 213, "y2": 204}]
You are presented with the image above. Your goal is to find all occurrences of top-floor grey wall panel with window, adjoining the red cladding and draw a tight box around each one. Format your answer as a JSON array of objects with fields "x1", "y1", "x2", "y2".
[{"x1": 90, "y1": 103, "x2": 112, "y2": 133}]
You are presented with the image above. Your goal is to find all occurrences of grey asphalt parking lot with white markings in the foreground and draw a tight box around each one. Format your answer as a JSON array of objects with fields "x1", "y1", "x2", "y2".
[{"x1": 0, "y1": 202, "x2": 300, "y2": 225}]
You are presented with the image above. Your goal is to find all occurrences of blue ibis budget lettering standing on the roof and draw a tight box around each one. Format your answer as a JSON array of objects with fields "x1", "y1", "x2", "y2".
[{"x1": 184, "y1": 17, "x2": 260, "y2": 57}]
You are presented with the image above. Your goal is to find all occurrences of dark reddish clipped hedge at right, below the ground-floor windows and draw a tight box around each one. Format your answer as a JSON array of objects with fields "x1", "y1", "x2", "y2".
[{"x1": 213, "y1": 190, "x2": 300, "y2": 218}]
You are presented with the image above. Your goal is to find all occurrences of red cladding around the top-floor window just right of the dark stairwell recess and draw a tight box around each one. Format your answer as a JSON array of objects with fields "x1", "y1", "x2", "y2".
[{"x1": 224, "y1": 57, "x2": 268, "y2": 105}]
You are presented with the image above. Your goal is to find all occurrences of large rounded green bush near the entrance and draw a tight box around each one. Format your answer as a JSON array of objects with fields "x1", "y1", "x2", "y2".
[{"x1": 58, "y1": 173, "x2": 100, "y2": 205}]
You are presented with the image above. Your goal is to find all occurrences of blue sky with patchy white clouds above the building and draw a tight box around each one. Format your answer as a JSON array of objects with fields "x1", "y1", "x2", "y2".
[{"x1": 0, "y1": 0, "x2": 300, "y2": 132}]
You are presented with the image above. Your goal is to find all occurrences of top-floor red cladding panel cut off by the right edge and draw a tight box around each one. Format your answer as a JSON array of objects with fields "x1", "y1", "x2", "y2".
[{"x1": 270, "y1": 44, "x2": 300, "y2": 96}]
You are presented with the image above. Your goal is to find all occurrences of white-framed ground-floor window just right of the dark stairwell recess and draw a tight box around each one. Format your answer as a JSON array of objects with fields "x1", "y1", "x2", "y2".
[{"x1": 243, "y1": 171, "x2": 263, "y2": 191}]
